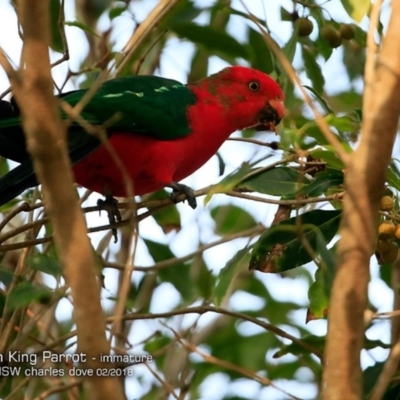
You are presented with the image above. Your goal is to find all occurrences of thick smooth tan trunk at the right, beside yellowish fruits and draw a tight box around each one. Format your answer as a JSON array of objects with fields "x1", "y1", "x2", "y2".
[{"x1": 323, "y1": 2, "x2": 400, "y2": 400}]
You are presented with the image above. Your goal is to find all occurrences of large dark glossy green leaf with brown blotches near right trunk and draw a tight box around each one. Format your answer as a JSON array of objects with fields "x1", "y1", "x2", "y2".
[{"x1": 249, "y1": 210, "x2": 341, "y2": 272}]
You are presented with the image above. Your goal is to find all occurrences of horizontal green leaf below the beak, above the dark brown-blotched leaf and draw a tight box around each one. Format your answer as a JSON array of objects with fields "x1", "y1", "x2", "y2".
[{"x1": 237, "y1": 167, "x2": 309, "y2": 196}]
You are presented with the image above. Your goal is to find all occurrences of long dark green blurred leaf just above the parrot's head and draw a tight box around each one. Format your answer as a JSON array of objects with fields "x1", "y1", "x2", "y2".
[{"x1": 172, "y1": 22, "x2": 248, "y2": 58}]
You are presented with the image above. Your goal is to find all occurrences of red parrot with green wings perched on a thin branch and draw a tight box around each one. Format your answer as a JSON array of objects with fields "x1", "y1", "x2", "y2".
[{"x1": 0, "y1": 66, "x2": 285, "y2": 214}]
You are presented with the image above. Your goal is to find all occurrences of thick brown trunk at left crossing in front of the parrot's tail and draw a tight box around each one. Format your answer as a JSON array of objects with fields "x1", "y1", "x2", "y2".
[{"x1": 2, "y1": 0, "x2": 125, "y2": 399}]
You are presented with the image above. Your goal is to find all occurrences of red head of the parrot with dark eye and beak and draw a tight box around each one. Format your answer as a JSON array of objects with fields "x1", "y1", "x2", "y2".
[{"x1": 195, "y1": 66, "x2": 285, "y2": 131}]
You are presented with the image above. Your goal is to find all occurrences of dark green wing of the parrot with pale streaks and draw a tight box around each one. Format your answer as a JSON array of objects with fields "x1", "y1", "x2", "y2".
[{"x1": 63, "y1": 76, "x2": 196, "y2": 140}]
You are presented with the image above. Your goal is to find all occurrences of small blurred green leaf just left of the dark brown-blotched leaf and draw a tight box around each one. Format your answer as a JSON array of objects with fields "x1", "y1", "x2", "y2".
[{"x1": 211, "y1": 204, "x2": 257, "y2": 236}]
